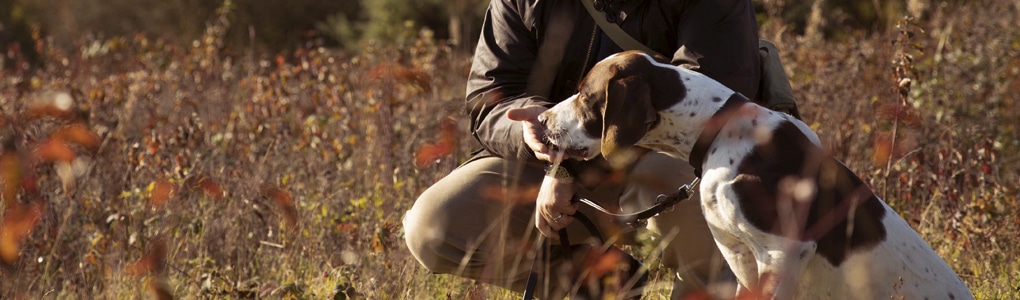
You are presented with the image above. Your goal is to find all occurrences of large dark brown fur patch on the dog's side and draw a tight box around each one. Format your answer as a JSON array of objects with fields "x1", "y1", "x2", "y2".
[{"x1": 733, "y1": 122, "x2": 885, "y2": 266}]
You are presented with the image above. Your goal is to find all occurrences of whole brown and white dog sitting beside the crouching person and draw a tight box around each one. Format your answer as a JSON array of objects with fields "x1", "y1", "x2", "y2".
[{"x1": 539, "y1": 51, "x2": 973, "y2": 300}]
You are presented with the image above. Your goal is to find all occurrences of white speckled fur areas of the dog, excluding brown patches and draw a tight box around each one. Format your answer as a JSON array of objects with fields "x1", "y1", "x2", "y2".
[{"x1": 547, "y1": 53, "x2": 973, "y2": 300}]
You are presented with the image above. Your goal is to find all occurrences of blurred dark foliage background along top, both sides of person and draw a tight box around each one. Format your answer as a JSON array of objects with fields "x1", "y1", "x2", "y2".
[{"x1": 0, "y1": 0, "x2": 960, "y2": 61}]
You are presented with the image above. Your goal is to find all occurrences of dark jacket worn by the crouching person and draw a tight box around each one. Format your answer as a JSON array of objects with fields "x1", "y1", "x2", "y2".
[{"x1": 466, "y1": 0, "x2": 760, "y2": 170}]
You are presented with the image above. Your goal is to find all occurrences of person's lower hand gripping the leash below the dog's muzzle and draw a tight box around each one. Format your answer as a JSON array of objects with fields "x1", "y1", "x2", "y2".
[{"x1": 534, "y1": 176, "x2": 577, "y2": 240}]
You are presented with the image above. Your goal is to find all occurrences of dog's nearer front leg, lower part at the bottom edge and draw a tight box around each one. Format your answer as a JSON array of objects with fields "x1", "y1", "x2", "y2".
[{"x1": 752, "y1": 241, "x2": 818, "y2": 300}]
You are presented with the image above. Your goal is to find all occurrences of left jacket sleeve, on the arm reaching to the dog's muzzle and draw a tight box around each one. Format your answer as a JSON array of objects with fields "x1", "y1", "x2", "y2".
[{"x1": 466, "y1": 0, "x2": 553, "y2": 161}]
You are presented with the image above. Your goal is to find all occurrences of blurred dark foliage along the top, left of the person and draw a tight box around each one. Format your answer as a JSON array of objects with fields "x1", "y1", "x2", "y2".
[{"x1": 0, "y1": 0, "x2": 487, "y2": 60}]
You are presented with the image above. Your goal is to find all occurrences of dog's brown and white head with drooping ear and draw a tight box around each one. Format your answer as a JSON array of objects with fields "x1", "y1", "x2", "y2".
[{"x1": 539, "y1": 51, "x2": 685, "y2": 164}]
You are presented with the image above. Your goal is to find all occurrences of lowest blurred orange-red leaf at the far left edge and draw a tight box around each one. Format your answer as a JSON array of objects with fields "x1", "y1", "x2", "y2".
[{"x1": 0, "y1": 202, "x2": 45, "y2": 264}]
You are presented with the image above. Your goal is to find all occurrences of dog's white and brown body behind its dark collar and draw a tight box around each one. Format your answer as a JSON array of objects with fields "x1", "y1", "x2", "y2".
[{"x1": 702, "y1": 102, "x2": 973, "y2": 299}]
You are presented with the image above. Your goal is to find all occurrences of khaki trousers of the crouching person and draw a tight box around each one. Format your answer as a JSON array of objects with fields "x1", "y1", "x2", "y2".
[{"x1": 404, "y1": 152, "x2": 723, "y2": 296}]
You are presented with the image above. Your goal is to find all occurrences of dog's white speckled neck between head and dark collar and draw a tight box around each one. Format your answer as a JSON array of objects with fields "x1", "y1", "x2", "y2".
[{"x1": 638, "y1": 69, "x2": 735, "y2": 160}]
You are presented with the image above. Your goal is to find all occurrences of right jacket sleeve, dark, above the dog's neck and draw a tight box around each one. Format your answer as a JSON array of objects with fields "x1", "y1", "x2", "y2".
[{"x1": 672, "y1": 0, "x2": 761, "y2": 98}]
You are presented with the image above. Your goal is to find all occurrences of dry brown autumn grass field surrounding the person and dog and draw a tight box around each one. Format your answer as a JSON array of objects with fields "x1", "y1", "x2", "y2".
[{"x1": 0, "y1": 3, "x2": 1020, "y2": 299}]
